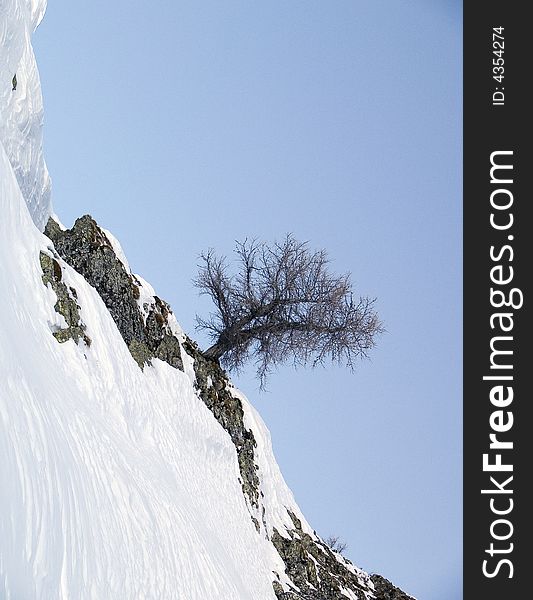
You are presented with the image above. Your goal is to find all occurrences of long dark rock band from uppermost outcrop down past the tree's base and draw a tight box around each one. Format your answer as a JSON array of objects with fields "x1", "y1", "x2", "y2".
[{"x1": 44, "y1": 215, "x2": 259, "y2": 510}]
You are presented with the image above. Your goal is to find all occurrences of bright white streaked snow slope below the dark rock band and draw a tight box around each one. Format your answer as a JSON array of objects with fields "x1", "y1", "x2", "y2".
[{"x1": 0, "y1": 139, "x2": 286, "y2": 600}]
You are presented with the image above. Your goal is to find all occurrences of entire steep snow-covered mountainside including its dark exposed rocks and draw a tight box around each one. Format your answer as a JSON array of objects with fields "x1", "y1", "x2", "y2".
[{"x1": 0, "y1": 0, "x2": 409, "y2": 600}]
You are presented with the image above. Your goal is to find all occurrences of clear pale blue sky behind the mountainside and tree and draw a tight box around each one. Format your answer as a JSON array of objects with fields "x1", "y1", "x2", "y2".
[{"x1": 34, "y1": 0, "x2": 462, "y2": 600}]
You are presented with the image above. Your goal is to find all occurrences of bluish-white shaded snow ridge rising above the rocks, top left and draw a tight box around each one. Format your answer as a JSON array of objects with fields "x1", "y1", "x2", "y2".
[{"x1": 0, "y1": 0, "x2": 52, "y2": 231}]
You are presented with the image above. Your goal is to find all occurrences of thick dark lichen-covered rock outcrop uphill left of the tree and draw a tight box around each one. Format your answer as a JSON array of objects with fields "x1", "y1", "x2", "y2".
[{"x1": 44, "y1": 215, "x2": 183, "y2": 369}]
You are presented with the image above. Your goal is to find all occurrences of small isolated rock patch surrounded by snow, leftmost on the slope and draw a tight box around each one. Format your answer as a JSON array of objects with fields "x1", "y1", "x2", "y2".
[{"x1": 39, "y1": 252, "x2": 91, "y2": 346}]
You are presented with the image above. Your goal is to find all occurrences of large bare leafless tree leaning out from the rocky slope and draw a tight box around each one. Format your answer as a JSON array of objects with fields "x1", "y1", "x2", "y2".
[{"x1": 194, "y1": 234, "x2": 383, "y2": 386}]
